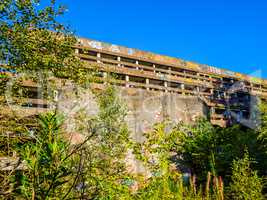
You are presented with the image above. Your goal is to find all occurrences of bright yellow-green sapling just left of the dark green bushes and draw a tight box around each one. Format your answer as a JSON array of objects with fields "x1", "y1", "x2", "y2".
[{"x1": 135, "y1": 122, "x2": 186, "y2": 200}]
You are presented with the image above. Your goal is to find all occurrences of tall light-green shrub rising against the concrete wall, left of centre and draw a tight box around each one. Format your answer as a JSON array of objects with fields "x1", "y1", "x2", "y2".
[{"x1": 73, "y1": 86, "x2": 131, "y2": 199}]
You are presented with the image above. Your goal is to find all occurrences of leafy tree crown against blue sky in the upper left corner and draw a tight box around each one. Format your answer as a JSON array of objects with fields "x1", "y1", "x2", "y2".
[{"x1": 0, "y1": 0, "x2": 80, "y2": 77}]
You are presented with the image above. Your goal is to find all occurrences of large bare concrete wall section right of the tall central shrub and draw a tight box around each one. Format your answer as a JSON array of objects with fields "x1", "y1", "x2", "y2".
[{"x1": 119, "y1": 88, "x2": 205, "y2": 141}]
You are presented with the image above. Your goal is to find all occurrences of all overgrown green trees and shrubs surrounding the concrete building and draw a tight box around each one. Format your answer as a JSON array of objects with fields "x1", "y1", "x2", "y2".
[{"x1": 0, "y1": 0, "x2": 267, "y2": 200}]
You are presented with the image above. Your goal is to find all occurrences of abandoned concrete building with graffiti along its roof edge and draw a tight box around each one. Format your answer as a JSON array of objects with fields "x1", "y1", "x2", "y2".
[{"x1": 0, "y1": 38, "x2": 267, "y2": 132}]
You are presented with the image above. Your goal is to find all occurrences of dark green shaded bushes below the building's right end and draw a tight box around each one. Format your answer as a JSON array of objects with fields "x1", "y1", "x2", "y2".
[{"x1": 174, "y1": 119, "x2": 266, "y2": 184}]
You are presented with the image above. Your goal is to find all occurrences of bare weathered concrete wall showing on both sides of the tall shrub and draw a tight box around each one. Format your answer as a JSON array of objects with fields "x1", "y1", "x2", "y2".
[{"x1": 58, "y1": 86, "x2": 206, "y2": 141}]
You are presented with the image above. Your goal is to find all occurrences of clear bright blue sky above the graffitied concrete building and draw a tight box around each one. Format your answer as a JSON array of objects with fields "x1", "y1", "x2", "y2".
[{"x1": 61, "y1": 0, "x2": 267, "y2": 78}]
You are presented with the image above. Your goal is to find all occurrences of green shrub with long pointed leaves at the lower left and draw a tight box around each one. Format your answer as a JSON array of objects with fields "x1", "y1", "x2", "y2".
[{"x1": 14, "y1": 113, "x2": 79, "y2": 199}]
